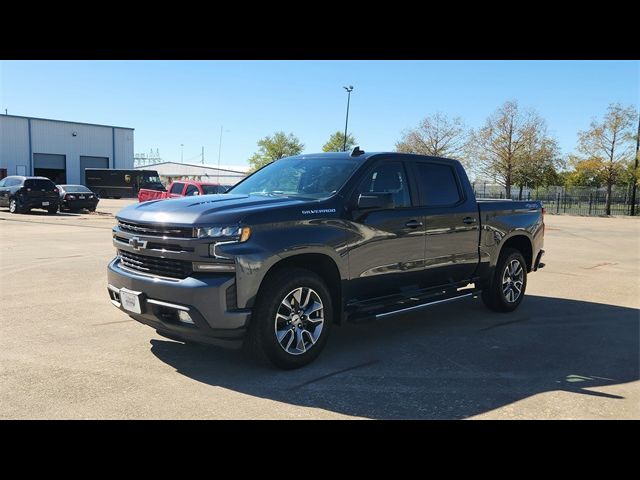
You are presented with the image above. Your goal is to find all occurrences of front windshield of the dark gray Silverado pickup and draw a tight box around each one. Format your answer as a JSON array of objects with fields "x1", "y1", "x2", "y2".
[{"x1": 228, "y1": 157, "x2": 359, "y2": 199}]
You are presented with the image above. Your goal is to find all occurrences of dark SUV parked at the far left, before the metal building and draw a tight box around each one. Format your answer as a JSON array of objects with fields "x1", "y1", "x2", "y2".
[{"x1": 0, "y1": 176, "x2": 60, "y2": 213}]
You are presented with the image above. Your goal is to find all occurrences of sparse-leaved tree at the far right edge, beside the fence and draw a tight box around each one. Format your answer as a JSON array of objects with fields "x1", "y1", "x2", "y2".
[{"x1": 578, "y1": 103, "x2": 637, "y2": 215}]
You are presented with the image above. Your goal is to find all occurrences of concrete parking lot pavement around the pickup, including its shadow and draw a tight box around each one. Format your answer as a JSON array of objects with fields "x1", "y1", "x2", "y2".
[{"x1": 0, "y1": 200, "x2": 640, "y2": 419}]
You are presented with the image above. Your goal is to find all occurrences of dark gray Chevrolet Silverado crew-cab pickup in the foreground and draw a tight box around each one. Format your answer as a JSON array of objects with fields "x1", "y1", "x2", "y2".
[{"x1": 107, "y1": 147, "x2": 544, "y2": 369}]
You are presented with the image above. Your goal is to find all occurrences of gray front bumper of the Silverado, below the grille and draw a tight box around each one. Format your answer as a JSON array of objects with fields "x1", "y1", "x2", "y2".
[{"x1": 107, "y1": 258, "x2": 251, "y2": 348}]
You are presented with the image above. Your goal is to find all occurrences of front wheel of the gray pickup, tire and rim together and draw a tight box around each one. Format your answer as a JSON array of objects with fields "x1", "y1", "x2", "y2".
[{"x1": 246, "y1": 268, "x2": 333, "y2": 369}]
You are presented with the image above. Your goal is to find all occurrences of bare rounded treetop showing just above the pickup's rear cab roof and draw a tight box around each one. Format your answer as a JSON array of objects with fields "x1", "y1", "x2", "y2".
[{"x1": 396, "y1": 112, "x2": 467, "y2": 160}]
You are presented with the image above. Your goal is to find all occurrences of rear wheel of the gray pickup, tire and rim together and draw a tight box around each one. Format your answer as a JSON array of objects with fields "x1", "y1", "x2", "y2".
[{"x1": 482, "y1": 248, "x2": 527, "y2": 312}]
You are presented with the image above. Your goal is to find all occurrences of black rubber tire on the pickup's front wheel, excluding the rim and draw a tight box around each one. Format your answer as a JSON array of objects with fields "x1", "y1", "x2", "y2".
[{"x1": 244, "y1": 268, "x2": 333, "y2": 370}]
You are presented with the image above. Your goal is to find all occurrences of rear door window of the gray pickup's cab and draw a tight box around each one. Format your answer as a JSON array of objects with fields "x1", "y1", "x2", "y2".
[{"x1": 415, "y1": 163, "x2": 462, "y2": 207}]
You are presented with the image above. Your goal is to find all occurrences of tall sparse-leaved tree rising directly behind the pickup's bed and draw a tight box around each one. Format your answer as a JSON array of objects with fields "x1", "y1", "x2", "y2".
[{"x1": 469, "y1": 100, "x2": 547, "y2": 197}]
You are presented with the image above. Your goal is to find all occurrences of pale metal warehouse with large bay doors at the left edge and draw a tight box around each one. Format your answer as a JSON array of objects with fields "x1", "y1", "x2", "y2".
[{"x1": 0, "y1": 115, "x2": 133, "y2": 184}]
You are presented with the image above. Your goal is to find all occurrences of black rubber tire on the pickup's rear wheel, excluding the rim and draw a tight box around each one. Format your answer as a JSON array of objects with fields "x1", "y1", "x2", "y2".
[{"x1": 482, "y1": 248, "x2": 527, "y2": 312}]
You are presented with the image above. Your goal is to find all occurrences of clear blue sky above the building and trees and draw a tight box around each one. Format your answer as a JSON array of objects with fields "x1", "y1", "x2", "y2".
[{"x1": 0, "y1": 60, "x2": 640, "y2": 168}]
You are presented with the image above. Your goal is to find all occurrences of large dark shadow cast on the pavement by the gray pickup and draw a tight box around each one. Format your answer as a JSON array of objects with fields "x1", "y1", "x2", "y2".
[{"x1": 151, "y1": 296, "x2": 640, "y2": 419}]
